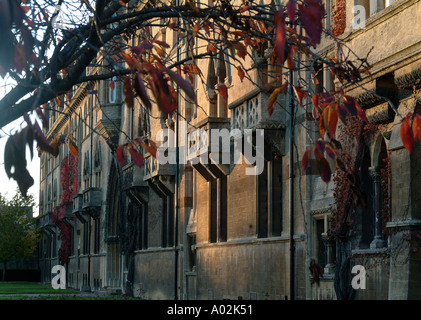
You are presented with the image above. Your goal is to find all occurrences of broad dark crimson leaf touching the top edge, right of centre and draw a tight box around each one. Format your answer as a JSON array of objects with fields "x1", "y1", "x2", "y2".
[{"x1": 298, "y1": 0, "x2": 325, "y2": 45}]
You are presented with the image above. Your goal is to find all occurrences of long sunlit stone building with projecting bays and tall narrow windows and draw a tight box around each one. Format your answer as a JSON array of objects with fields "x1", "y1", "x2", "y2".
[{"x1": 39, "y1": 0, "x2": 421, "y2": 299}]
